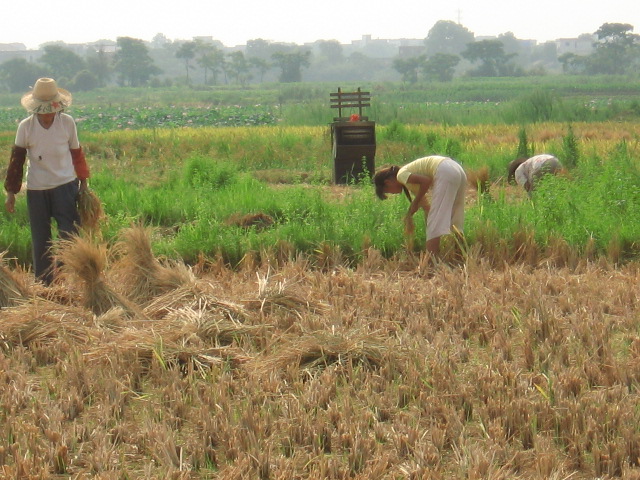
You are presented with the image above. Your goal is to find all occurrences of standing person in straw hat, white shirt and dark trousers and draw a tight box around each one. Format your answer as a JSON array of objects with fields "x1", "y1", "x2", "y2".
[{"x1": 4, "y1": 78, "x2": 89, "y2": 285}]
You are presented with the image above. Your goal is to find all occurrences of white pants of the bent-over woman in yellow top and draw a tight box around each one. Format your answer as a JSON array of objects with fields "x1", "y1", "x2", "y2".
[{"x1": 427, "y1": 159, "x2": 467, "y2": 240}]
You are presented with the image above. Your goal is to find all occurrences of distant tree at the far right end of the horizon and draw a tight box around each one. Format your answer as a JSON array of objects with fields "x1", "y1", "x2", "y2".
[{"x1": 589, "y1": 23, "x2": 640, "y2": 75}]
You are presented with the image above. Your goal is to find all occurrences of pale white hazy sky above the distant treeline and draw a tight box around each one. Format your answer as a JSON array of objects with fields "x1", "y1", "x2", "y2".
[{"x1": 0, "y1": 0, "x2": 640, "y2": 48}]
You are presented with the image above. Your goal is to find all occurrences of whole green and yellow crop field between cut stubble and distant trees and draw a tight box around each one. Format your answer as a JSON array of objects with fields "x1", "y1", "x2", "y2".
[{"x1": 0, "y1": 78, "x2": 640, "y2": 265}]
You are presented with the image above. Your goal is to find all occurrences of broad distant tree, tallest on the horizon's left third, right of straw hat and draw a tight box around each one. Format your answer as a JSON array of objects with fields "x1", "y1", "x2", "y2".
[{"x1": 114, "y1": 37, "x2": 161, "y2": 87}]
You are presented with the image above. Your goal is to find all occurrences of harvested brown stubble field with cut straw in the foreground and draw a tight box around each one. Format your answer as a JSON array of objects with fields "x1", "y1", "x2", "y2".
[{"x1": 0, "y1": 231, "x2": 640, "y2": 479}]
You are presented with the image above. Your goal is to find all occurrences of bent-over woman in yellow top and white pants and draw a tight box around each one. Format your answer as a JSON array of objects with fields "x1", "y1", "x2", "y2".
[{"x1": 374, "y1": 155, "x2": 467, "y2": 255}]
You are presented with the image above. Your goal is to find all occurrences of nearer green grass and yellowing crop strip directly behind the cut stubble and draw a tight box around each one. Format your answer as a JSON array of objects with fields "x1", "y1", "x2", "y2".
[{"x1": 0, "y1": 123, "x2": 640, "y2": 265}]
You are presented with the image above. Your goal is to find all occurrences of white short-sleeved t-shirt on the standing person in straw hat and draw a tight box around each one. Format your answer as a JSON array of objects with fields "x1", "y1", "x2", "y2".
[{"x1": 15, "y1": 113, "x2": 80, "y2": 190}]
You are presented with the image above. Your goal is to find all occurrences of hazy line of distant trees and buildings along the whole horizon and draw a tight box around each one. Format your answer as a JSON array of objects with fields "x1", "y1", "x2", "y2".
[{"x1": 0, "y1": 21, "x2": 640, "y2": 92}]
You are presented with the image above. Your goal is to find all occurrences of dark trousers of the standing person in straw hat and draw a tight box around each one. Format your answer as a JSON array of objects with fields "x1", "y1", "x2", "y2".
[{"x1": 27, "y1": 180, "x2": 80, "y2": 285}]
